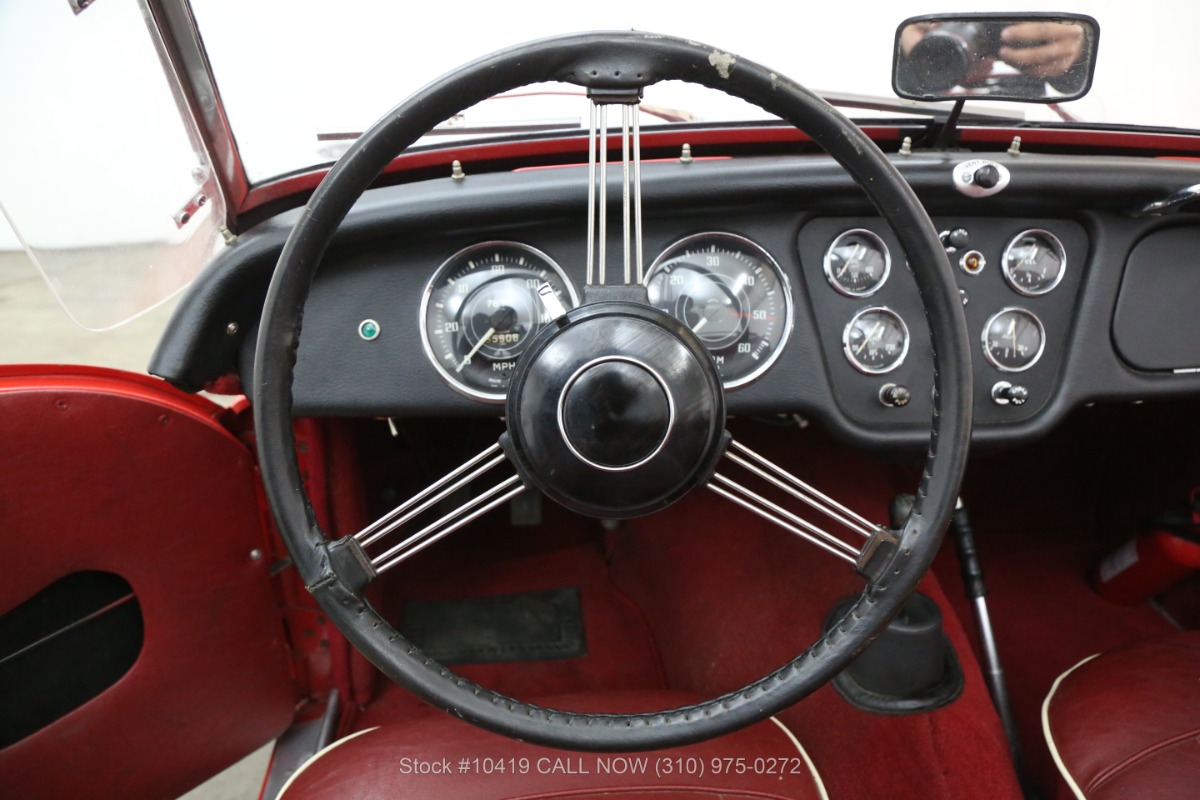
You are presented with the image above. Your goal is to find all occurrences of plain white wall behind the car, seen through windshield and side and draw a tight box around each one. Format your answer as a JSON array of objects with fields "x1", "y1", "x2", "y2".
[{"x1": 0, "y1": 0, "x2": 1200, "y2": 248}]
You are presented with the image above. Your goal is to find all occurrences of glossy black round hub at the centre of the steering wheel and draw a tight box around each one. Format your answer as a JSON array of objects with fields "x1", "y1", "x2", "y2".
[{"x1": 502, "y1": 301, "x2": 726, "y2": 518}]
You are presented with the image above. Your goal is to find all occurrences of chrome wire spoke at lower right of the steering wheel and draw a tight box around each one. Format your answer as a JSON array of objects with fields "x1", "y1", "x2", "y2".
[{"x1": 708, "y1": 440, "x2": 898, "y2": 578}]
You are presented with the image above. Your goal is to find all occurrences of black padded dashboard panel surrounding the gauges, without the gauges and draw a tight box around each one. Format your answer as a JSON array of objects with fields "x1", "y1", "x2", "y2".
[{"x1": 150, "y1": 152, "x2": 1200, "y2": 449}]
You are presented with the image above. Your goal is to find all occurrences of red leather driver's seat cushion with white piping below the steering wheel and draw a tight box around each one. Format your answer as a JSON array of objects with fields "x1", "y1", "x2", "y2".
[{"x1": 281, "y1": 691, "x2": 824, "y2": 800}]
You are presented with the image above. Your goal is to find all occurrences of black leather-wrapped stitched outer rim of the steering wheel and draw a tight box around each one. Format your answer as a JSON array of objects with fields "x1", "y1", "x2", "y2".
[{"x1": 253, "y1": 31, "x2": 972, "y2": 751}]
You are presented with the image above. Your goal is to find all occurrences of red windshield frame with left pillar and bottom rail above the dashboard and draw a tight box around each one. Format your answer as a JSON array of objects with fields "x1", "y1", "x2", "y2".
[{"x1": 152, "y1": 0, "x2": 1200, "y2": 234}]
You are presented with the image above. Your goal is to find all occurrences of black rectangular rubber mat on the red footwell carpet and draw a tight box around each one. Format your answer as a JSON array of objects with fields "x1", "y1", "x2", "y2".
[{"x1": 401, "y1": 587, "x2": 588, "y2": 664}]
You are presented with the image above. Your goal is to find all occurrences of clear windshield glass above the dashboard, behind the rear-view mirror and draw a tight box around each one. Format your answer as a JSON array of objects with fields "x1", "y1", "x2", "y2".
[{"x1": 193, "y1": 0, "x2": 1200, "y2": 181}]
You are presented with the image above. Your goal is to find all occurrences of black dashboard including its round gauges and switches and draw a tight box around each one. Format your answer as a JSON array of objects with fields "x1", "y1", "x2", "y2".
[{"x1": 151, "y1": 152, "x2": 1200, "y2": 446}]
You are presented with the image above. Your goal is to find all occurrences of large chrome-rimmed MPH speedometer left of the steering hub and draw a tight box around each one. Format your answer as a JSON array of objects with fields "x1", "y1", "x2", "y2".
[{"x1": 421, "y1": 241, "x2": 578, "y2": 402}]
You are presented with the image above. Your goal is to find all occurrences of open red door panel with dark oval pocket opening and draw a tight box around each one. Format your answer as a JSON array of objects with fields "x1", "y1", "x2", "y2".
[{"x1": 0, "y1": 367, "x2": 295, "y2": 799}]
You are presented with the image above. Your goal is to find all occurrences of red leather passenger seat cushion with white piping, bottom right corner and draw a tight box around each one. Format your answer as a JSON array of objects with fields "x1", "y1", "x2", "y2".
[{"x1": 1044, "y1": 631, "x2": 1200, "y2": 800}]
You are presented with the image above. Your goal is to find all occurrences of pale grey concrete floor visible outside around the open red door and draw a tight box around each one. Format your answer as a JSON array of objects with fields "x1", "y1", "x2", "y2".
[{"x1": 0, "y1": 252, "x2": 272, "y2": 800}]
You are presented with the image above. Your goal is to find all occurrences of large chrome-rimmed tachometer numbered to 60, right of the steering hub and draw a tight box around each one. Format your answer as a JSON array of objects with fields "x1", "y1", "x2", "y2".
[{"x1": 646, "y1": 233, "x2": 792, "y2": 389}]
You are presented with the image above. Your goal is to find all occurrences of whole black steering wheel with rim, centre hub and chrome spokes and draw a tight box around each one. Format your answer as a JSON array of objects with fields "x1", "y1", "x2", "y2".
[{"x1": 253, "y1": 31, "x2": 971, "y2": 752}]
